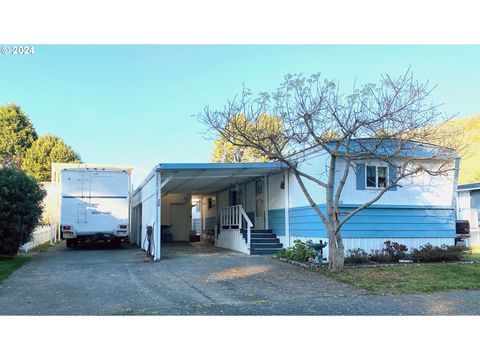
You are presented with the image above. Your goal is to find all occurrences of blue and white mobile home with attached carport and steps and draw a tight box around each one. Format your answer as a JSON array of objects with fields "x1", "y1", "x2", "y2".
[{"x1": 131, "y1": 139, "x2": 458, "y2": 260}]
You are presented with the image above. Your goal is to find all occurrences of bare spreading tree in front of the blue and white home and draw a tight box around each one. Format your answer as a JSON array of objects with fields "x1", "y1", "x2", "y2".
[{"x1": 198, "y1": 71, "x2": 458, "y2": 271}]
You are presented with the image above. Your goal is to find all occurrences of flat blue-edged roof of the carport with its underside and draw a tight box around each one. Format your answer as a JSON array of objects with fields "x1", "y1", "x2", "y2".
[{"x1": 155, "y1": 162, "x2": 286, "y2": 195}]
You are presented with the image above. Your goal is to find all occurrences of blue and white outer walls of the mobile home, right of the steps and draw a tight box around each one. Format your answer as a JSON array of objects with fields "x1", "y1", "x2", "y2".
[{"x1": 269, "y1": 150, "x2": 455, "y2": 255}]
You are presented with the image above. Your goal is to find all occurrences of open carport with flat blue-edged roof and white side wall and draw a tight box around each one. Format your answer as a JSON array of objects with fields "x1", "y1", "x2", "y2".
[{"x1": 130, "y1": 162, "x2": 285, "y2": 260}]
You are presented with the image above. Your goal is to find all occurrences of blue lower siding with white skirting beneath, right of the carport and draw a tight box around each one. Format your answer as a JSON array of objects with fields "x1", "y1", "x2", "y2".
[{"x1": 284, "y1": 205, "x2": 455, "y2": 255}]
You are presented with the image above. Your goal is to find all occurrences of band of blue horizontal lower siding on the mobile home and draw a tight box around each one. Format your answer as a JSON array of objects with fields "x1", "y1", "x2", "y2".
[{"x1": 269, "y1": 205, "x2": 455, "y2": 238}]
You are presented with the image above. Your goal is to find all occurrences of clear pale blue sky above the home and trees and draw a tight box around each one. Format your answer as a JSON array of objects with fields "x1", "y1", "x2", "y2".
[{"x1": 0, "y1": 45, "x2": 480, "y2": 184}]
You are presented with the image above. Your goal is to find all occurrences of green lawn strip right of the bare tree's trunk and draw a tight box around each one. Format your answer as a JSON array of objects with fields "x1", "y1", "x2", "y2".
[{"x1": 319, "y1": 262, "x2": 480, "y2": 294}]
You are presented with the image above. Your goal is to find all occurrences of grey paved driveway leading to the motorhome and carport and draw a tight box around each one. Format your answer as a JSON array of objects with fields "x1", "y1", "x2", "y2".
[{"x1": 0, "y1": 243, "x2": 480, "y2": 315}]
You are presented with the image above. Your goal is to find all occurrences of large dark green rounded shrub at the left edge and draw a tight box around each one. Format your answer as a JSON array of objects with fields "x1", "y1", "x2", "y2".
[{"x1": 0, "y1": 167, "x2": 45, "y2": 256}]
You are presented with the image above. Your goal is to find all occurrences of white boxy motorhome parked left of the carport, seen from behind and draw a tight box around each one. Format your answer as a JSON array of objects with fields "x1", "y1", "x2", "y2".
[{"x1": 52, "y1": 163, "x2": 132, "y2": 247}]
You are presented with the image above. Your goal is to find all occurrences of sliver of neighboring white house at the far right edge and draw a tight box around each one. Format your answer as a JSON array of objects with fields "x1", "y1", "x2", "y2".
[{"x1": 457, "y1": 183, "x2": 480, "y2": 246}]
